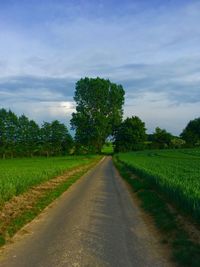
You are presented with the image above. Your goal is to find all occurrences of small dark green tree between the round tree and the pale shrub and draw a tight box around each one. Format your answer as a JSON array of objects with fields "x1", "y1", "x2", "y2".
[{"x1": 152, "y1": 127, "x2": 173, "y2": 149}]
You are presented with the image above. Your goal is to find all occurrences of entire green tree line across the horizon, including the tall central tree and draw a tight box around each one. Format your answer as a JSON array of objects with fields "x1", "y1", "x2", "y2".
[{"x1": 0, "y1": 77, "x2": 200, "y2": 158}]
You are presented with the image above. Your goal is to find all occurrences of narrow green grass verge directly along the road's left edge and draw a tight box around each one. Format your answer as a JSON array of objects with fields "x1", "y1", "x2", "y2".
[{"x1": 0, "y1": 158, "x2": 100, "y2": 246}]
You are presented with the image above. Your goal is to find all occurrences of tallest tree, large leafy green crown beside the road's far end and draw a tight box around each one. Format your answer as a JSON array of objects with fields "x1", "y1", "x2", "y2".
[{"x1": 71, "y1": 78, "x2": 124, "y2": 152}]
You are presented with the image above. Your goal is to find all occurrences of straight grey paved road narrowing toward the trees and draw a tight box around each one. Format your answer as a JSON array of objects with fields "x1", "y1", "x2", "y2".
[{"x1": 0, "y1": 157, "x2": 172, "y2": 267}]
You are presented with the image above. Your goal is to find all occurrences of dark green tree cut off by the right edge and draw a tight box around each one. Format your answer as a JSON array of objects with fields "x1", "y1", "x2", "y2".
[{"x1": 181, "y1": 118, "x2": 200, "y2": 146}]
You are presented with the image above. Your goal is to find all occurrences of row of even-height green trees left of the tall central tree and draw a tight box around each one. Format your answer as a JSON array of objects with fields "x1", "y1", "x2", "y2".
[{"x1": 0, "y1": 109, "x2": 73, "y2": 158}]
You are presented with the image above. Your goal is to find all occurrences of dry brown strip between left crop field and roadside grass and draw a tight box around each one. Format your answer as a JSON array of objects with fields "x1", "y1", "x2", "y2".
[{"x1": 0, "y1": 157, "x2": 99, "y2": 245}]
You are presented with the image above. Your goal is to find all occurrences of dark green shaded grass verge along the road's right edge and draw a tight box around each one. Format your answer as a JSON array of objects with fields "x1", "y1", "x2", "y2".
[{"x1": 114, "y1": 157, "x2": 200, "y2": 267}]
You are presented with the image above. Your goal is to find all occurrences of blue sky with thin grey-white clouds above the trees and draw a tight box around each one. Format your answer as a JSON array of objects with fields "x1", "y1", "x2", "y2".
[{"x1": 0, "y1": 0, "x2": 200, "y2": 135}]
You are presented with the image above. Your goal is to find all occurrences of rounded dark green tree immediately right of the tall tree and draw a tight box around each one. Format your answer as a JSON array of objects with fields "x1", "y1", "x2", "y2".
[{"x1": 114, "y1": 116, "x2": 146, "y2": 152}]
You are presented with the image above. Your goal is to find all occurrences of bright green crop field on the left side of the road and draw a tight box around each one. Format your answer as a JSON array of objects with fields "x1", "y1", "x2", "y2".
[{"x1": 0, "y1": 155, "x2": 97, "y2": 205}]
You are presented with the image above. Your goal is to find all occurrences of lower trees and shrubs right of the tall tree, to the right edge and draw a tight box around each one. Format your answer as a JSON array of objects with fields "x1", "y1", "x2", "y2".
[{"x1": 114, "y1": 116, "x2": 200, "y2": 152}]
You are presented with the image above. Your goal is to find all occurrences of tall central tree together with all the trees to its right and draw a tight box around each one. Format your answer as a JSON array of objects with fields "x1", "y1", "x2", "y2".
[{"x1": 71, "y1": 78, "x2": 200, "y2": 152}]
